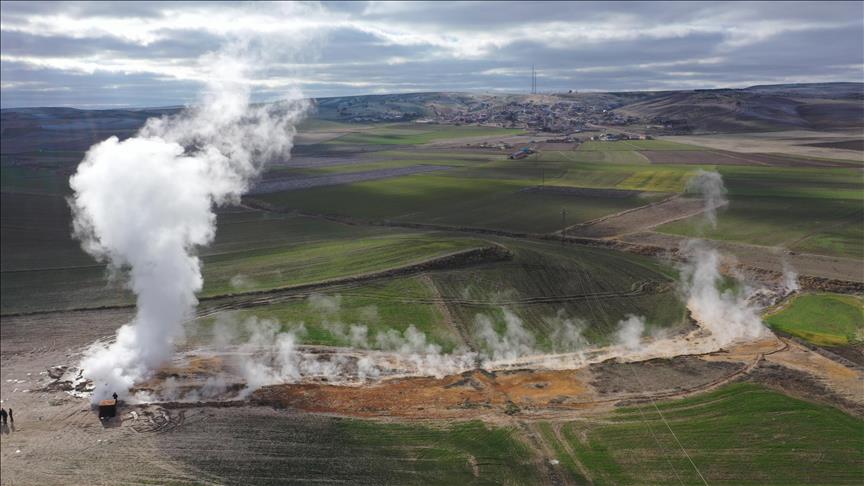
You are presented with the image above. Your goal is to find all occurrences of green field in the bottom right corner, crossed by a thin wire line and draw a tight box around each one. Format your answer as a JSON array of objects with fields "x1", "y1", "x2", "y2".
[{"x1": 543, "y1": 384, "x2": 864, "y2": 485}]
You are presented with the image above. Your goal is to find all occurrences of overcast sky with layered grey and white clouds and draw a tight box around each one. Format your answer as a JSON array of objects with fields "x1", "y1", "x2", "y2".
[{"x1": 0, "y1": 1, "x2": 864, "y2": 108}]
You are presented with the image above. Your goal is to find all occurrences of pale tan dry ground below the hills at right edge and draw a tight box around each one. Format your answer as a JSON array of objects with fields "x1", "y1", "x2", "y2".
[{"x1": 660, "y1": 130, "x2": 864, "y2": 162}]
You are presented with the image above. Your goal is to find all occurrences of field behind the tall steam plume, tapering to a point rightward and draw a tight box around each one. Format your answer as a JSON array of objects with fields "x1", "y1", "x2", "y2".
[{"x1": 0, "y1": 193, "x2": 482, "y2": 313}]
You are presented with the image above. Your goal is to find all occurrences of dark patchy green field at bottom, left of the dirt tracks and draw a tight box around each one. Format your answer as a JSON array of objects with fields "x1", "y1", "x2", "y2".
[{"x1": 162, "y1": 414, "x2": 542, "y2": 485}]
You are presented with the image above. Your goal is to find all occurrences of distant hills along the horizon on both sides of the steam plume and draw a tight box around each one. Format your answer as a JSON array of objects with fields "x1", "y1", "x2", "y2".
[{"x1": 0, "y1": 83, "x2": 864, "y2": 151}]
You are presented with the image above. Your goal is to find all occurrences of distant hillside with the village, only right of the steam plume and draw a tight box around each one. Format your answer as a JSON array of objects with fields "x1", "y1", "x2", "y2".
[{"x1": 317, "y1": 83, "x2": 864, "y2": 133}]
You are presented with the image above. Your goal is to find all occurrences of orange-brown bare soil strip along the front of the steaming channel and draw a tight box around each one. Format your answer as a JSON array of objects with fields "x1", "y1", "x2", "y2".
[{"x1": 253, "y1": 338, "x2": 844, "y2": 421}]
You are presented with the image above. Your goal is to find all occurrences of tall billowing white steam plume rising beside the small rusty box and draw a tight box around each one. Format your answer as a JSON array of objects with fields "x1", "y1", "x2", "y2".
[{"x1": 69, "y1": 49, "x2": 307, "y2": 400}]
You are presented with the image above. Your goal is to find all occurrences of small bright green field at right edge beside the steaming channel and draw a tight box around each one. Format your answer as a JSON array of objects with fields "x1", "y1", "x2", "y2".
[{"x1": 765, "y1": 294, "x2": 864, "y2": 346}]
